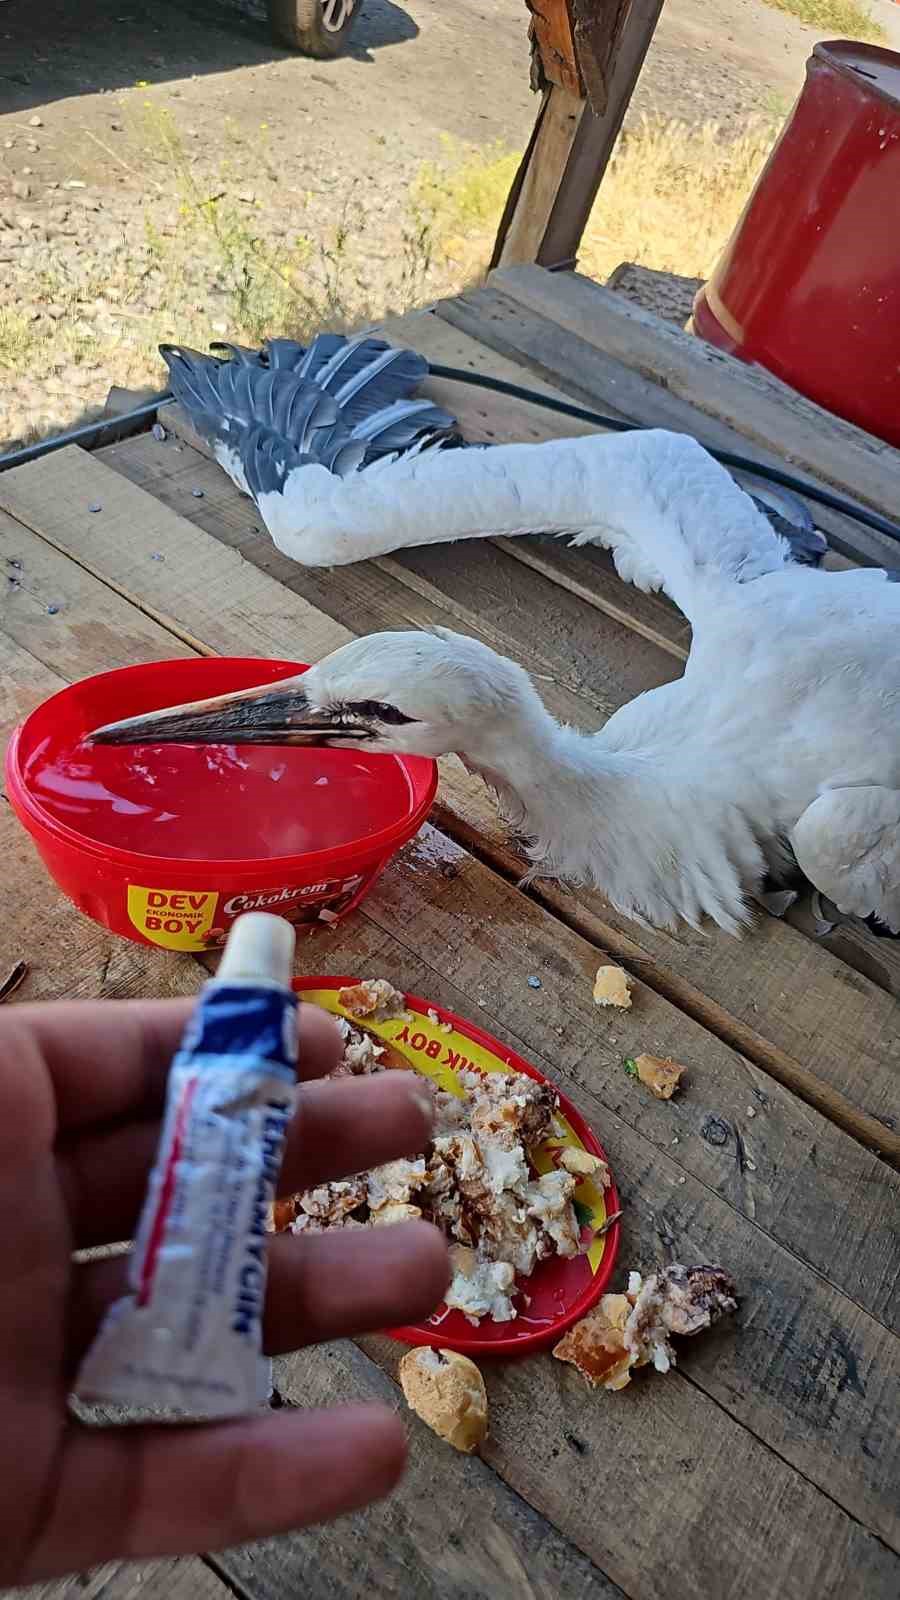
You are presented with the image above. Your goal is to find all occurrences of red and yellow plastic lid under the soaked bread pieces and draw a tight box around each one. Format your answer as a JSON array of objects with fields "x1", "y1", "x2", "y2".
[{"x1": 293, "y1": 978, "x2": 620, "y2": 1357}]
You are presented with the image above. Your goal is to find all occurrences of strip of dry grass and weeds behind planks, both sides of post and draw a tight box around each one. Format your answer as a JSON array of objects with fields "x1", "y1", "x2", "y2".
[{"x1": 0, "y1": 109, "x2": 777, "y2": 437}]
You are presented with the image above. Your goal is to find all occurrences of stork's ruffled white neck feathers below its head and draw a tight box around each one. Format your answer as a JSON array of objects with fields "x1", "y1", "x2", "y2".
[{"x1": 463, "y1": 696, "x2": 764, "y2": 933}]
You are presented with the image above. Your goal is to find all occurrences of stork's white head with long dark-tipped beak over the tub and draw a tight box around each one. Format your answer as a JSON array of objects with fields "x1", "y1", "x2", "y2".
[{"x1": 93, "y1": 629, "x2": 540, "y2": 755}]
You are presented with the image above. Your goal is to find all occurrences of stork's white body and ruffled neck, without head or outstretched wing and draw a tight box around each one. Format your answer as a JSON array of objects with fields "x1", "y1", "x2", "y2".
[{"x1": 496, "y1": 568, "x2": 900, "y2": 931}]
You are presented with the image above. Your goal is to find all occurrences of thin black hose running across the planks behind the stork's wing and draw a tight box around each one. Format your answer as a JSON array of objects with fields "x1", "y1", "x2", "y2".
[{"x1": 0, "y1": 362, "x2": 900, "y2": 544}]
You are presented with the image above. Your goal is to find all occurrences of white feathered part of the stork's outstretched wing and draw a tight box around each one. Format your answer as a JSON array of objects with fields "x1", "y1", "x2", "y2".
[{"x1": 258, "y1": 430, "x2": 790, "y2": 610}]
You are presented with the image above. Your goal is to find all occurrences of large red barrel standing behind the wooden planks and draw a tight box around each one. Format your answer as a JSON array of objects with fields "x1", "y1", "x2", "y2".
[{"x1": 692, "y1": 40, "x2": 900, "y2": 445}]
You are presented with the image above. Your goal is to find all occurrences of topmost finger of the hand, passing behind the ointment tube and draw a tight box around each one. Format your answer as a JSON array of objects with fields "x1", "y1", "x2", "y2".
[{"x1": 0, "y1": 998, "x2": 341, "y2": 1133}]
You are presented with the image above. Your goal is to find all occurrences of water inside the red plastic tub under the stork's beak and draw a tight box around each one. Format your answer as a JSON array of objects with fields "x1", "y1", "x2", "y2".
[{"x1": 26, "y1": 738, "x2": 412, "y2": 861}]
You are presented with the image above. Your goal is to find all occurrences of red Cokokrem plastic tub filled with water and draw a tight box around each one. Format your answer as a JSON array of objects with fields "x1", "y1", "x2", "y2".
[{"x1": 6, "y1": 656, "x2": 437, "y2": 950}]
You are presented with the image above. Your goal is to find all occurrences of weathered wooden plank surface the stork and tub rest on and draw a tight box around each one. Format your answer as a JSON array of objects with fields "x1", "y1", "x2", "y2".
[{"x1": 0, "y1": 269, "x2": 900, "y2": 1600}]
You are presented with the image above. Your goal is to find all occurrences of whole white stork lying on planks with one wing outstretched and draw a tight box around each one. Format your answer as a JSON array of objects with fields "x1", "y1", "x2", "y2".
[{"x1": 102, "y1": 336, "x2": 900, "y2": 933}]
